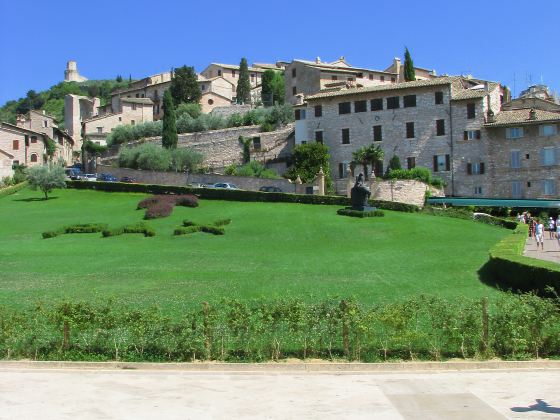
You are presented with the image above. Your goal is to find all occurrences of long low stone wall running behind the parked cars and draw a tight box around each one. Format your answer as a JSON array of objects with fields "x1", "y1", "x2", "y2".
[{"x1": 97, "y1": 164, "x2": 295, "y2": 192}]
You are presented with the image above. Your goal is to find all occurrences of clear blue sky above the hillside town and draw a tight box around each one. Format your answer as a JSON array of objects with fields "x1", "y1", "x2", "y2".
[{"x1": 0, "y1": 0, "x2": 560, "y2": 104}]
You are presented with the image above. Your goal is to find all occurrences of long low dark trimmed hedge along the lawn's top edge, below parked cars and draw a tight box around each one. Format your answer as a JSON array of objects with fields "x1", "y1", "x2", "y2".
[{"x1": 67, "y1": 181, "x2": 419, "y2": 213}]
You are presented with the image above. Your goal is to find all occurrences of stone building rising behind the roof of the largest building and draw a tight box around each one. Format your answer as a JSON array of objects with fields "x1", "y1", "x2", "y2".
[{"x1": 284, "y1": 57, "x2": 435, "y2": 104}]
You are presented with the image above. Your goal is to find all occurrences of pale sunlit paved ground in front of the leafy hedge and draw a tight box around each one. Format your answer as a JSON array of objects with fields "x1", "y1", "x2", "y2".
[{"x1": 0, "y1": 366, "x2": 560, "y2": 420}]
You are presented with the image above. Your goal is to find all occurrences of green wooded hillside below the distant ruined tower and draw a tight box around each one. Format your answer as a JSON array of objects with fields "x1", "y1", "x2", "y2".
[{"x1": 0, "y1": 80, "x2": 129, "y2": 127}]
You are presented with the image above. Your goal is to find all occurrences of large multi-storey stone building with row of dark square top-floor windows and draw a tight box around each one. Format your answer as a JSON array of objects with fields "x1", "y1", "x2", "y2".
[{"x1": 295, "y1": 77, "x2": 508, "y2": 197}]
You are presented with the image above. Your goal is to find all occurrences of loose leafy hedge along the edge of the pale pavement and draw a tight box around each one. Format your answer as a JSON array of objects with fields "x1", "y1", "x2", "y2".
[{"x1": 0, "y1": 293, "x2": 560, "y2": 362}]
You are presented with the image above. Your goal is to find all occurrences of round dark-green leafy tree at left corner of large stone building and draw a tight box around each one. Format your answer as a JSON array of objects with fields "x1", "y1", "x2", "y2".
[{"x1": 285, "y1": 143, "x2": 333, "y2": 191}]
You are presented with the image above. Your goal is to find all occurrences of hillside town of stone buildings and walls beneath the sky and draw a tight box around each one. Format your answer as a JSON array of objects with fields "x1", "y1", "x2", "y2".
[{"x1": 0, "y1": 57, "x2": 560, "y2": 199}]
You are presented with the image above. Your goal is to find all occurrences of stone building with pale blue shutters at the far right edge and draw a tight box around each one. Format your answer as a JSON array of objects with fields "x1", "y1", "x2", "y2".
[{"x1": 484, "y1": 108, "x2": 560, "y2": 198}]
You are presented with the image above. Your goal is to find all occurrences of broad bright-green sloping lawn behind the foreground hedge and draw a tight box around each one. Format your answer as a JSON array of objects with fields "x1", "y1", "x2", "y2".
[{"x1": 0, "y1": 189, "x2": 510, "y2": 310}]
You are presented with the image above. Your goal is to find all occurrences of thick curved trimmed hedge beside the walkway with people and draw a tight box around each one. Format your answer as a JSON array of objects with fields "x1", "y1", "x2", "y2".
[{"x1": 487, "y1": 224, "x2": 560, "y2": 295}]
